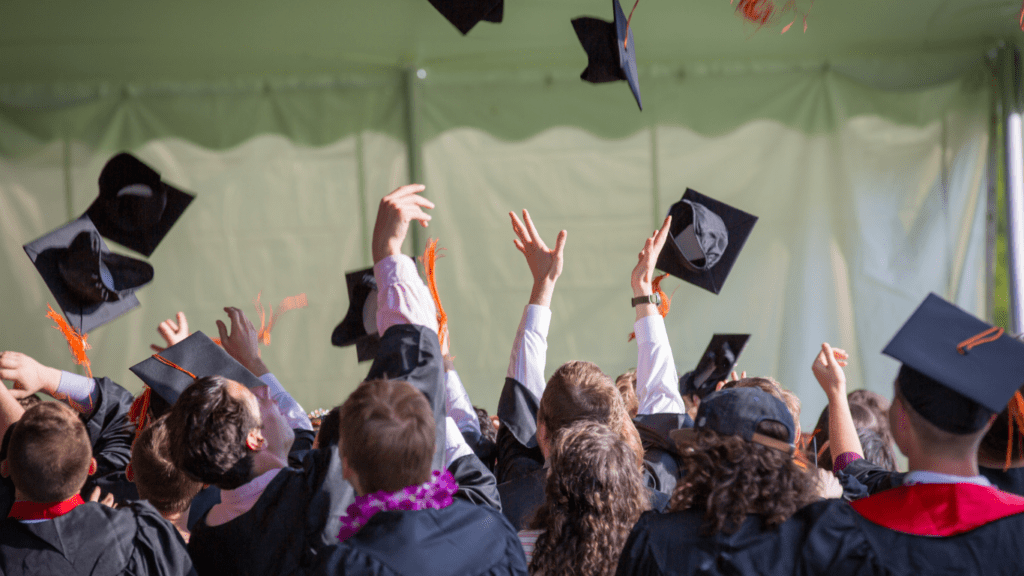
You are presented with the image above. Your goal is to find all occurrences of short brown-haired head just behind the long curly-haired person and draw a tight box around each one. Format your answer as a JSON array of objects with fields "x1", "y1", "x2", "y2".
[{"x1": 537, "y1": 361, "x2": 643, "y2": 465}]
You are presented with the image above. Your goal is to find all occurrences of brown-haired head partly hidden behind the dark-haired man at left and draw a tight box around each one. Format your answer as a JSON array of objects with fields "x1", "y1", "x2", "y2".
[{"x1": 131, "y1": 415, "x2": 203, "y2": 516}]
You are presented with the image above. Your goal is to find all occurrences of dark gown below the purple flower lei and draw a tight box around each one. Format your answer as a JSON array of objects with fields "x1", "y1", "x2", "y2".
[{"x1": 311, "y1": 500, "x2": 528, "y2": 576}]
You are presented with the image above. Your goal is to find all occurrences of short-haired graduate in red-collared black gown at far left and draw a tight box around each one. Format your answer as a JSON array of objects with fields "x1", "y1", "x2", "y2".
[{"x1": 0, "y1": 397, "x2": 196, "y2": 576}]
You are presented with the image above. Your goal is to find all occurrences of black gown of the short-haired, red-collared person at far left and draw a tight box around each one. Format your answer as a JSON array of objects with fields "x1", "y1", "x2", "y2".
[{"x1": 0, "y1": 502, "x2": 196, "y2": 576}]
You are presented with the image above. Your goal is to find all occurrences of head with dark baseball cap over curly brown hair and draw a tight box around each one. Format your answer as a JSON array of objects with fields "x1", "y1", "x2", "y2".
[{"x1": 670, "y1": 386, "x2": 817, "y2": 534}]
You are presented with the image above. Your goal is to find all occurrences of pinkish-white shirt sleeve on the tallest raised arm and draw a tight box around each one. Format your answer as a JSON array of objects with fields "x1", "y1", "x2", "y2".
[{"x1": 374, "y1": 254, "x2": 437, "y2": 335}]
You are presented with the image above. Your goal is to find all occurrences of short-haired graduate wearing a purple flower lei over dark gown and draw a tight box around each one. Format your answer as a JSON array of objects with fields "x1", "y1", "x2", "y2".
[{"x1": 312, "y1": 377, "x2": 527, "y2": 576}]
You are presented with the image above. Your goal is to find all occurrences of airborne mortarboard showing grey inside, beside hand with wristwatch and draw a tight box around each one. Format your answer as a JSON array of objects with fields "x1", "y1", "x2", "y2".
[{"x1": 657, "y1": 189, "x2": 758, "y2": 294}]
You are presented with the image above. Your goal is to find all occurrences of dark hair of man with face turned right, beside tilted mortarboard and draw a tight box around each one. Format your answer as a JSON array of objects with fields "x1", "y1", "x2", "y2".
[{"x1": 167, "y1": 376, "x2": 261, "y2": 490}]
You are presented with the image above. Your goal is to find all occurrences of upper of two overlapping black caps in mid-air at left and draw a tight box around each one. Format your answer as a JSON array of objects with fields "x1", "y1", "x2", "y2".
[{"x1": 86, "y1": 152, "x2": 195, "y2": 256}]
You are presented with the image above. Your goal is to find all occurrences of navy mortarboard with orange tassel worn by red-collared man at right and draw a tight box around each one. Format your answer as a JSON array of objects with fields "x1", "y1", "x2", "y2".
[{"x1": 883, "y1": 294, "x2": 1024, "y2": 434}]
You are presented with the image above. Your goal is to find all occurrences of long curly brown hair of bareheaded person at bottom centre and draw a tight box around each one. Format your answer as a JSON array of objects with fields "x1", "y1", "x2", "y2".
[{"x1": 528, "y1": 420, "x2": 650, "y2": 576}]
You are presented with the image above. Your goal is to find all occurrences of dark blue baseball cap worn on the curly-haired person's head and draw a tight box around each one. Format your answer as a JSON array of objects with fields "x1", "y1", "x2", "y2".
[{"x1": 670, "y1": 388, "x2": 797, "y2": 454}]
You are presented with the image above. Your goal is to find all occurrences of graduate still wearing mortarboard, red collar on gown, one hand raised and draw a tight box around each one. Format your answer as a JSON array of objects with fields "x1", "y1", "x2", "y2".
[{"x1": 802, "y1": 294, "x2": 1024, "y2": 576}]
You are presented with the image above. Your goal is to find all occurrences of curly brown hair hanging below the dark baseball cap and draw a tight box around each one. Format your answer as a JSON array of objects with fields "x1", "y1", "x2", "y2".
[{"x1": 670, "y1": 420, "x2": 818, "y2": 535}]
